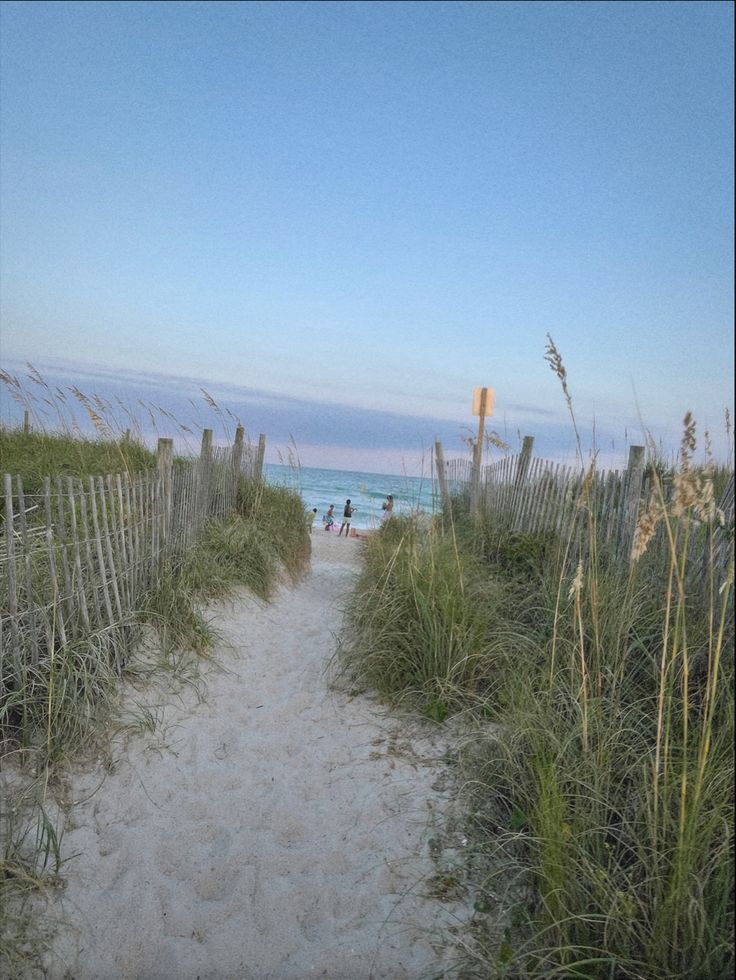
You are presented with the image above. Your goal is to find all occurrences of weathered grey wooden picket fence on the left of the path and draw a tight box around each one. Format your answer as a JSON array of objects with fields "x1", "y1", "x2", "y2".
[{"x1": 0, "y1": 428, "x2": 265, "y2": 696}]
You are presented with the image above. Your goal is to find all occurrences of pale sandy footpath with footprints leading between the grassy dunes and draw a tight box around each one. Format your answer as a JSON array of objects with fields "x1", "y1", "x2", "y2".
[{"x1": 30, "y1": 529, "x2": 465, "y2": 980}]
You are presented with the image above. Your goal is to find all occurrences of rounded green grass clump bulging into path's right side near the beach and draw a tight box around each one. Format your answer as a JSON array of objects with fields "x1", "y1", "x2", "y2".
[{"x1": 343, "y1": 517, "x2": 506, "y2": 720}]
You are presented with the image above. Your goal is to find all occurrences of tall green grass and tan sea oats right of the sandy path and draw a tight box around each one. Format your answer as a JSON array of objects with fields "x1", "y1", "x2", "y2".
[{"x1": 341, "y1": 340, "x2": 734, "y2": 980}]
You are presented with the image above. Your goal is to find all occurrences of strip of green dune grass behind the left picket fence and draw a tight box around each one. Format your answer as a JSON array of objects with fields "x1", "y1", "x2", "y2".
[{"x1": 0, "y1": 427, "x2": 156, "y2": 494}]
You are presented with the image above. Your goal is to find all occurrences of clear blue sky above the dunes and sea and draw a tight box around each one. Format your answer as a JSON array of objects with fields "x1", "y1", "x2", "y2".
[{"x1": 0, "y1": 2, "x2": 734, "y2": 471}]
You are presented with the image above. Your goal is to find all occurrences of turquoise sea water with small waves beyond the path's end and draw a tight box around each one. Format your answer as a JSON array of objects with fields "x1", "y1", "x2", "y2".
[{"x1": 263, "y1": 463, "x2": 435, "y2": 529}]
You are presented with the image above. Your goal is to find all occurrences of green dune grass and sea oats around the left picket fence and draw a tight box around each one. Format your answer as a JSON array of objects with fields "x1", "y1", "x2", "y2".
[{"x1": 0, "y1": 365, "x2": 310, "y2": 976}]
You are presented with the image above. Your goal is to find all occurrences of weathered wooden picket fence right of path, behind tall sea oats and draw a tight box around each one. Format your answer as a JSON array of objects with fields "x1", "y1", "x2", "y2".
[{"x1": 436, "y1": 439, "x2": 734, "y2": 579}]
